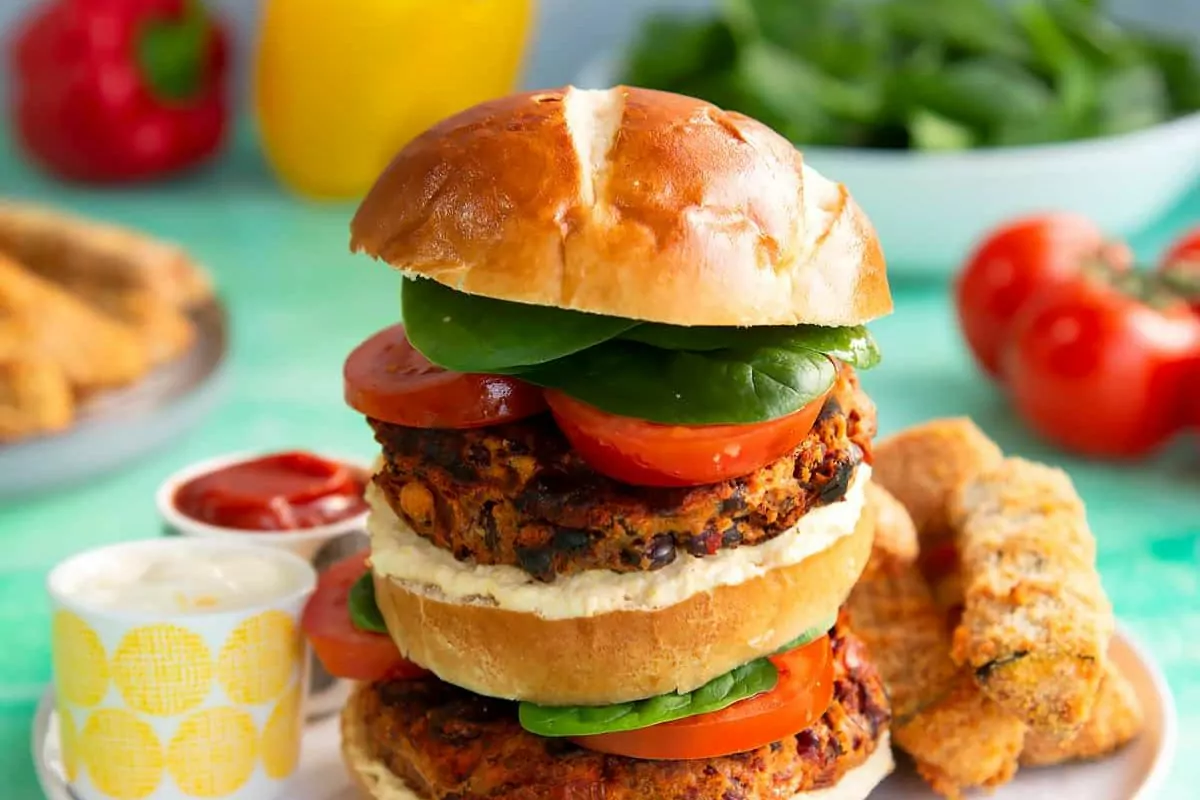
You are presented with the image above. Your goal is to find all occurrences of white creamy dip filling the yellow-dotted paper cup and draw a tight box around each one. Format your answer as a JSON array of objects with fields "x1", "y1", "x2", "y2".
[{"x1": 59, "y1": 541, "x2": 302, "y2": 614}]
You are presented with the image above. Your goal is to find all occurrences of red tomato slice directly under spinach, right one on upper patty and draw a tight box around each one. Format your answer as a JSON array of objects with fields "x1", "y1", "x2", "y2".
[{"x1": 546, "y1": 390, "x2": 828, "y2": 486}]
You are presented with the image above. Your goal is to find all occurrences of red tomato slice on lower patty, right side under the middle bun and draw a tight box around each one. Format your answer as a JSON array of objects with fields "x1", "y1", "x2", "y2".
[{"x1": 572, "y1": 636, "x2": 833, "y2": 760}]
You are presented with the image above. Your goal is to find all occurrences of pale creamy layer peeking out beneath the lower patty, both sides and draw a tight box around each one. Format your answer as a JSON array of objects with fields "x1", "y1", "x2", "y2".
[{"x1": 342, "y1": 687, "x2": 895, "y2": 800}]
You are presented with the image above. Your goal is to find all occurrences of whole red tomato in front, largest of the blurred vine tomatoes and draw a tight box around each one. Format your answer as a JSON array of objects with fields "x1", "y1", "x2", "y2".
[{"x1": 1004, "y1": 273, "x2": 1200, "y2": 457}]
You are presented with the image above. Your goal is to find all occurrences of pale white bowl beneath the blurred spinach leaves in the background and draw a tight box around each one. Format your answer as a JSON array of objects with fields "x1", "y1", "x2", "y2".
[{"x1": 577, "y1": 54, "x2": 1200, "y2": 276}]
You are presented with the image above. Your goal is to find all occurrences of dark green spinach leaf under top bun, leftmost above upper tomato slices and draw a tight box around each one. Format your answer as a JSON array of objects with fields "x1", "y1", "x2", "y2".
[{"x1": 401, "y1": 279, "x2": 637, "y2": 372}]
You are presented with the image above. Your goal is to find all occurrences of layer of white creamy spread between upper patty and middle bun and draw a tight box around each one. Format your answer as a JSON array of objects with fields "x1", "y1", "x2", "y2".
[{"x1": 366, "y1": 465, "x2": 871, "y2": 619}]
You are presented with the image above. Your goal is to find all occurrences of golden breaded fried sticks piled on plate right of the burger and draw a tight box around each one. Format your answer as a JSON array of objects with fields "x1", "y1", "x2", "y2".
[{"x1": 850, "y1": 419, "x2": 1176, "y2": 800}]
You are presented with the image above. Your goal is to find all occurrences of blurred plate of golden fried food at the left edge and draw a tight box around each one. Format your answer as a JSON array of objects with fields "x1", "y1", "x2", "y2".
[{"x1": 0, "y1": 200, "x2": 228, "y2": 497}]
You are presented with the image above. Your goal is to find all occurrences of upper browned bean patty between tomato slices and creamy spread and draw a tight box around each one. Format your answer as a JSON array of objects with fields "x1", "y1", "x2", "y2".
[{"x1": 370, "y1": 367, "x2": 875, "y2": 582}]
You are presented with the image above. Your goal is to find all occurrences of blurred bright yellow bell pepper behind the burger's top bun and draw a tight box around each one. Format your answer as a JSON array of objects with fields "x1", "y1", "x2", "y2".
[{"x1": 254, "y1": 0, "x2": 535, "y2": 198}]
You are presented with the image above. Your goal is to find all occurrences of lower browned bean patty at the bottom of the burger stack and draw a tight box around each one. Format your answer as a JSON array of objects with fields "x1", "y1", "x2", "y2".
[{"x1": 354, "y1": 621, "x2": 889, "y2": 800}]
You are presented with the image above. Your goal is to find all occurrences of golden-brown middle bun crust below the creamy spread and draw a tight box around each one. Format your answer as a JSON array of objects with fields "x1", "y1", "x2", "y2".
[{"x1": 376, "y1": 510, "x2": 875, "y2": 705}]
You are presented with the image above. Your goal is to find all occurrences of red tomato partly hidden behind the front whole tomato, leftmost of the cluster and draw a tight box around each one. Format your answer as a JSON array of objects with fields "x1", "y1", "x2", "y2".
[{"x1": 955, "y1": 213, "x2": 1133, "y2": 378}]
